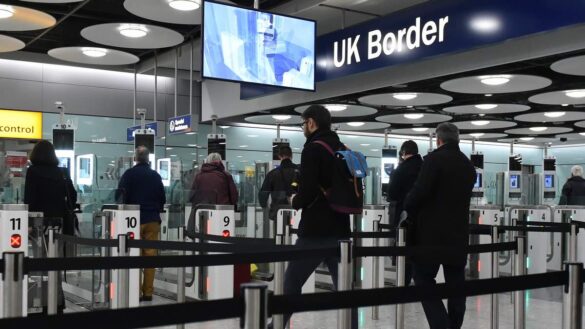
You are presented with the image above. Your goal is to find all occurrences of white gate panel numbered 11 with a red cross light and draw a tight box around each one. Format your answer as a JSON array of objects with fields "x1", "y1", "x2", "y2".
[{"x1": 0, "y1": 204, "x2": 28, "y2": 255}]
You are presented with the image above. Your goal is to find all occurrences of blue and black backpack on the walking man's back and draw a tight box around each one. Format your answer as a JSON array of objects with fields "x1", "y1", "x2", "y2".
[{"x1": 313, "y1": 141, "x2": 368, "y2": 214}]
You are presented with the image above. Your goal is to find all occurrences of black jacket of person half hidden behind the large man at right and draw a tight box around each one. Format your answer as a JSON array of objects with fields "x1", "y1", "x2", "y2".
[{"x1": 388, "y1": 154, "x2": 423, "y2": 226}]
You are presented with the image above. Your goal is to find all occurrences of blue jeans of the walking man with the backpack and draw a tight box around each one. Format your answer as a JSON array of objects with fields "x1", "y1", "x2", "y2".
[{"x1": 283, "y1": 237, "x2": 357, "y2": 328}]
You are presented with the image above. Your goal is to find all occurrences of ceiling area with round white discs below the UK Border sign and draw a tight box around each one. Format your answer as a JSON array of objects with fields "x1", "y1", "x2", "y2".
[{"x1": 225, "y1": 50, "x2": 585, "y2": 144}]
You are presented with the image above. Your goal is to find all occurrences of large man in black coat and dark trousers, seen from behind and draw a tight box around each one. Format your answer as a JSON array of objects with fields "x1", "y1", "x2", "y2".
[{"x1": 404, "y1": 123, "x2": 475, "y2": 329}]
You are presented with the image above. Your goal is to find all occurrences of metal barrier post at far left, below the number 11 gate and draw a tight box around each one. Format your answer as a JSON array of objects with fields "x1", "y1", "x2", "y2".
[{"x1": 2, "y1": 252, "x2": 24, "y2": 318}]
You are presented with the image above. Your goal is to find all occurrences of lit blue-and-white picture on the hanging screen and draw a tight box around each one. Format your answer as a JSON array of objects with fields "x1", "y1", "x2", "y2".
[{"x1": 203, "y1": 1, "x2": 315, "y2": 90}]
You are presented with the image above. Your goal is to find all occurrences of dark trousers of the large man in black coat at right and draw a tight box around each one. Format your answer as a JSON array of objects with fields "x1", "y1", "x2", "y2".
[{"x1": 414, "y1": 262, "x2": 466, "y2": 329}]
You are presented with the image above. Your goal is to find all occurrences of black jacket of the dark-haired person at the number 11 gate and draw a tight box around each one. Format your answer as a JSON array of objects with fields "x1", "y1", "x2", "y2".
[{"x1": 24, "y1": 165, "x2": 77, "y2": 223}]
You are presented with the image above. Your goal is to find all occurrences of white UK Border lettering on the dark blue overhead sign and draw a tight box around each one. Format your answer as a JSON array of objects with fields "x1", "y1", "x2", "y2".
[{"x1": 333, "y1": 16, "x2": 449, "y2": 68}]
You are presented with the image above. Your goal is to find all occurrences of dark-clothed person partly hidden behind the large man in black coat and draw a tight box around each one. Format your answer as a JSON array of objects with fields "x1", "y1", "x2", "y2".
[{"x1": 387, "y1": 140, "x2": 423, "y2": 286}]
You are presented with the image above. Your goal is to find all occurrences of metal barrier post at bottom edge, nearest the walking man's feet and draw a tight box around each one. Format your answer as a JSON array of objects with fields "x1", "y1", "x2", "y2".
[{"x1": 240, "y1": 283, "x2": 268, "y2": 329}]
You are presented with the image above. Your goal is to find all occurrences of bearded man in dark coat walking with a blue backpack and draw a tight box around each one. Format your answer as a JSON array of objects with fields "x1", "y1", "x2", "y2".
[{"x1": 274, "y1": 105, "x2": 363, "y2": 324}]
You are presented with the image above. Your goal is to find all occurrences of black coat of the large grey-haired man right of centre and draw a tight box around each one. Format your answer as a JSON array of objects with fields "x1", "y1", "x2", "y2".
[{"x1": 404, "y1": 143, "x2": 475, "y2": 263}]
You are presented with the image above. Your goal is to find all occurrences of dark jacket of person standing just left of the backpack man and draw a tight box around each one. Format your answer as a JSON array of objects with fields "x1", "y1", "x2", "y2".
[{"x1": 258, "y1": 159, "x2": 299, "y2": 220}]
